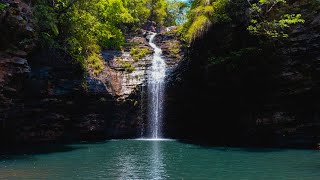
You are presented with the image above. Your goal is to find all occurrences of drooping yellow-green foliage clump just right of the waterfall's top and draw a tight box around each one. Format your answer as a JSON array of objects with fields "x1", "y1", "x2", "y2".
[{"x1": 180, "y1": 0, "x2": 230, "y2": 42}]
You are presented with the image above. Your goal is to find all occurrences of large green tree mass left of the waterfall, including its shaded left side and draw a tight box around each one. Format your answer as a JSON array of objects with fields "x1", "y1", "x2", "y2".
[{"x1": 34, "y1": 0, "x2": 137, "y2": 74}]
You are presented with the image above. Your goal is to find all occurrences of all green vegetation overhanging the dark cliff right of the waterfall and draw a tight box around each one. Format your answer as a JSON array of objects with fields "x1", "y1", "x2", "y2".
[{"x1": 180, "y1": 0, "x2": 304, "y2": 42}]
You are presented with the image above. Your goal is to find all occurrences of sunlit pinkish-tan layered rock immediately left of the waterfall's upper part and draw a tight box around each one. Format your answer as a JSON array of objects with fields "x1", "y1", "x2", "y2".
[{"x1": 88, "y1": 34, "x2": 153, "y2": 100}]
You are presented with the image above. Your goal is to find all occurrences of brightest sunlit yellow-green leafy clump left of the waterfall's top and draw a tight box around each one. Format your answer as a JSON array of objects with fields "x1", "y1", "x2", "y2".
[{"x1": 66, "y1": 0, "x2": 133, "y2": 74}]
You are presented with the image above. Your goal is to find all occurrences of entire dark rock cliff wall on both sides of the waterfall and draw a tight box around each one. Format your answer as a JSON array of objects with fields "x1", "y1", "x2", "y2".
[{"x1": 5, "y1": 1, "x2": 320, "y2": 147}]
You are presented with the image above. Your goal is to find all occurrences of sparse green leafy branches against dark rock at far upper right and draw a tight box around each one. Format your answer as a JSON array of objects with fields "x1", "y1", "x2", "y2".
[{"x1": 247, "y1": 0, "x2": 304, "y2": 38}]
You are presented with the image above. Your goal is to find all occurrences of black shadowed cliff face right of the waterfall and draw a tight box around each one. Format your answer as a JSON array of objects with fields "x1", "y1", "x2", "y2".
[{"x1": 166, "y1": 0, "x2": 320, "y2": 147}]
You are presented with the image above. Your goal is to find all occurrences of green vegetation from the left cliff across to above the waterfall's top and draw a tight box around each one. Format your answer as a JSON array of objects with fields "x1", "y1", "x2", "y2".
[{"x1": 33, "y1": 0, "x2": 180, "y2": 74}]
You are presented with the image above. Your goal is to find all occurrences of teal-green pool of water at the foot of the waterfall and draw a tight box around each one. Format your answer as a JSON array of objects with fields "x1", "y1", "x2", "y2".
[{"x1": 0, "y1": 140, "x2": 320, "y2": 180}]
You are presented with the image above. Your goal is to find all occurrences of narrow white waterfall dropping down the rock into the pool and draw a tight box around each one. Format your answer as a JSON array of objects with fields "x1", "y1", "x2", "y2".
[{"x1": 148, "y1": 33, "x2": 166, "y2": 139}]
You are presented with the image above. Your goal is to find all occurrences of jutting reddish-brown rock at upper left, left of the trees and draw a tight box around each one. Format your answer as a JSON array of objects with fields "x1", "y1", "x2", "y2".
[{"x1": 0, "y1": 1, "x2": 34, "y2": 100}]
